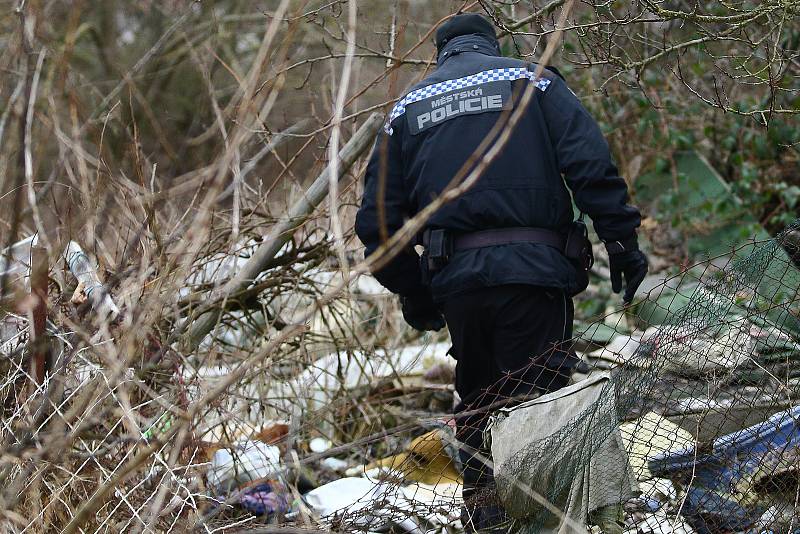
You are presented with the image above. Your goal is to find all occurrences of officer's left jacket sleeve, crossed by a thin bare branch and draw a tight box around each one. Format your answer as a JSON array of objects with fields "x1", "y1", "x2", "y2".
[{"x1": 356, "y1": 125, "x2": 428, "y2": 295}]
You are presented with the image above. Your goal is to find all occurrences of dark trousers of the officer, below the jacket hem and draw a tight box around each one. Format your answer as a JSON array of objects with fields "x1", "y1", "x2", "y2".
[{"x1": 444, "y1": 285, "x2": 577, "y2": 531}]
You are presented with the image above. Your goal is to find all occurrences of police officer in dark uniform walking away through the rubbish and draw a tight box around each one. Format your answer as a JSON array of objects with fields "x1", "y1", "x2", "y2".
[{"x1": 356, "y1": 13, "x2": 647, "y2": 531}]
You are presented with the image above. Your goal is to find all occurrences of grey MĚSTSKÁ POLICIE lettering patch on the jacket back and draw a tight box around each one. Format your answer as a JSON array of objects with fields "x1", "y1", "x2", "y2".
[{"x1": 406, "y1": 80, "x2": 511, "y2": 135}]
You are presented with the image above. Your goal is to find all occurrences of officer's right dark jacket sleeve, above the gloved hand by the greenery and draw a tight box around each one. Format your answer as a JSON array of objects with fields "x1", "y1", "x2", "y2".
[{"x1": 538, "y1": 76, "x2": 641, "y2": 242}]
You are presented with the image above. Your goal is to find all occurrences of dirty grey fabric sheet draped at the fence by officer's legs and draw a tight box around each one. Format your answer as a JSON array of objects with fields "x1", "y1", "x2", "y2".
[{"x1": 487, "y1": 373, "x2": 639, "y2": 534}]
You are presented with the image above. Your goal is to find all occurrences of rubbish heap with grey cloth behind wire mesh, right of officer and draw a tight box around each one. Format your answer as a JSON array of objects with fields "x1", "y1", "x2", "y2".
[{"x1": 492, "y1": 220, "x2": 800, "y2": 534}]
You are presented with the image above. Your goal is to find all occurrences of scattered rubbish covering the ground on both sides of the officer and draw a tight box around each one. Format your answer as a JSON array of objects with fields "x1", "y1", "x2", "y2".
[{"x1": 0, "y1": 216, "x2": 800, "y2": 534}]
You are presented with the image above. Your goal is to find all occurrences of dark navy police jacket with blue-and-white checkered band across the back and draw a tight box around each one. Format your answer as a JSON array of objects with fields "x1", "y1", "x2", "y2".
[{"x1": 356, "y1": 35, "x2": 640, "y2": 301}]
